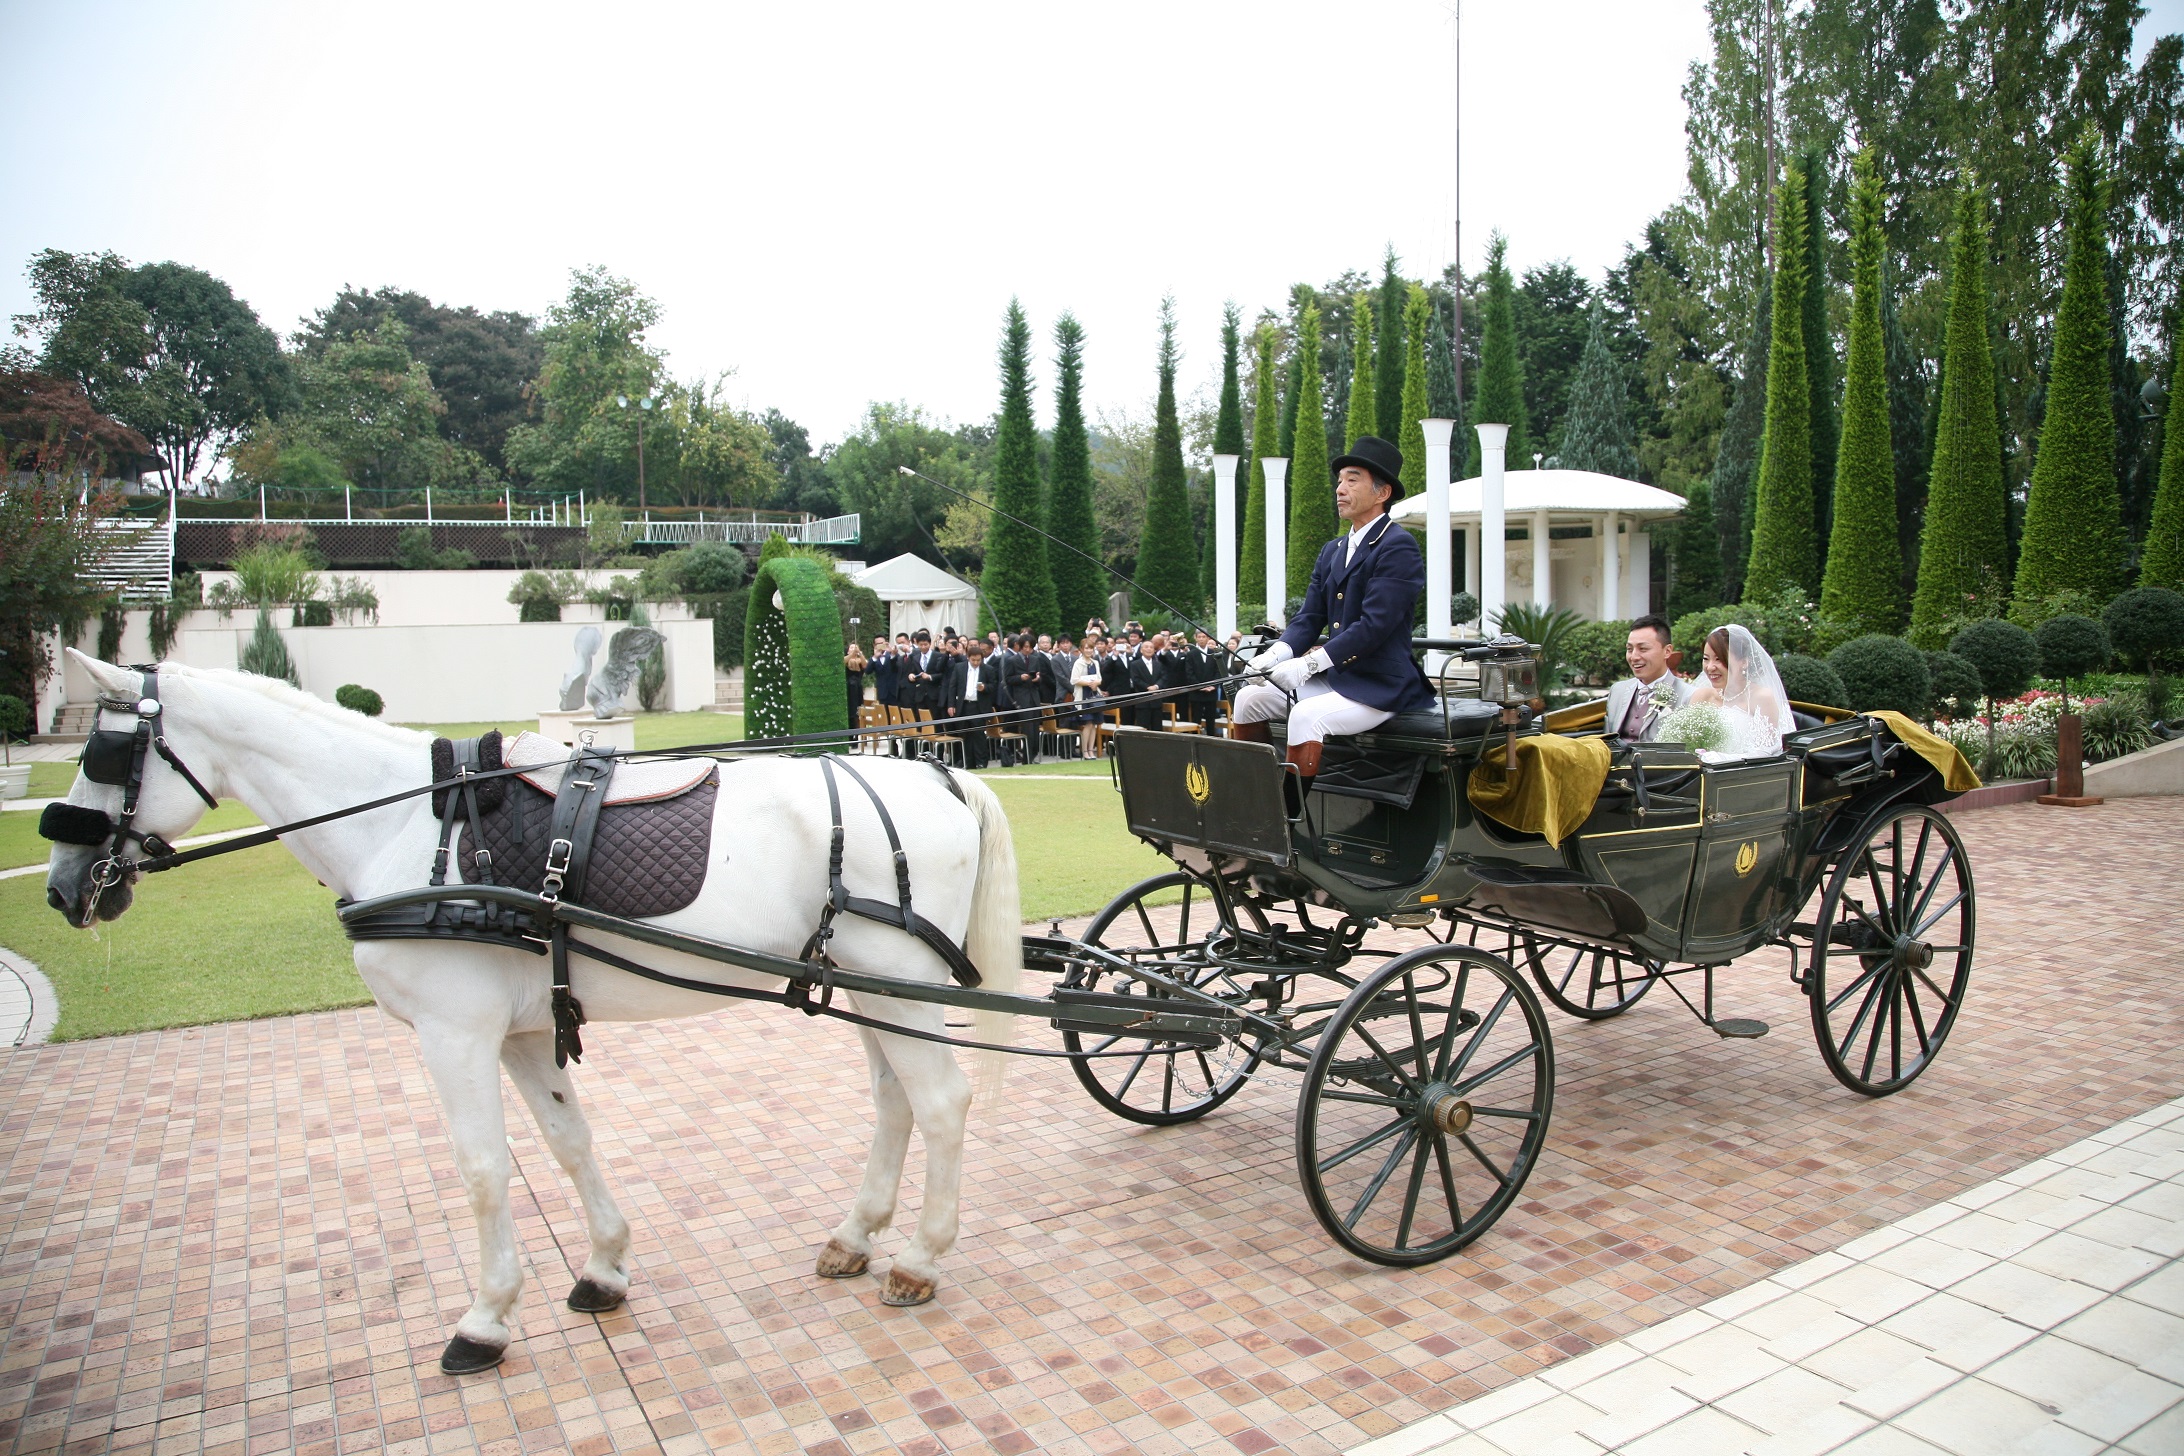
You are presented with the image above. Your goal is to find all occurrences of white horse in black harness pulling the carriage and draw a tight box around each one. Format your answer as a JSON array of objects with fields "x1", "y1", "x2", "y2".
[{"x1": 46, "y1": 648, "x2": 1022, "y2": 1373}]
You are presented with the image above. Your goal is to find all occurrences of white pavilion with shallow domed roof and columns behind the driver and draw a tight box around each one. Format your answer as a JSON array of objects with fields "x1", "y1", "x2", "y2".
[{"x1": 1391, "y1": 469, "x2": 1684, "y2": 622}]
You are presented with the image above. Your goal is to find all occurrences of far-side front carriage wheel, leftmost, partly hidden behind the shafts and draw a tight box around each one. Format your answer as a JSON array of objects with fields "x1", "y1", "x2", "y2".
[{"x1": 1061, "y1": 871, "x2": 1258, "y2": 1126}]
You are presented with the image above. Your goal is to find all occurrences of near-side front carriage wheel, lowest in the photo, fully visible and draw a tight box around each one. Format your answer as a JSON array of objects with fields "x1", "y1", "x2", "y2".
[{"x1": 1297, "y1": 945, "x2": 1555, "y2": 1264}]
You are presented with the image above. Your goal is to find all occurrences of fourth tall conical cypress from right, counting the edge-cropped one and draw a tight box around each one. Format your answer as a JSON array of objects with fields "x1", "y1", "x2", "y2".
[{"x1": 1819, "y1": 148, "x2": 1904, "y2": 635}]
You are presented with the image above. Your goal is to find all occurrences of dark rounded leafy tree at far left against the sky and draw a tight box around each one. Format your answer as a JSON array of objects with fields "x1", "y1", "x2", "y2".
[{"x1": 15, "y1": 249, "x2": 290, "y2": 482}]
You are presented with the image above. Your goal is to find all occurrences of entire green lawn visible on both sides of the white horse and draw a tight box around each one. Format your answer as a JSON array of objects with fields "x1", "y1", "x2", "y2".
[{"x1": 0, "y1": 764, "x2": 1168, "y2": 1039}]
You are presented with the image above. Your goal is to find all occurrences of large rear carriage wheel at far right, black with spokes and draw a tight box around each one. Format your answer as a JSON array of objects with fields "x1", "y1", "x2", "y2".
[{"x1": 1806, "y1": 805, "x2": 1974, "y2": 1096}]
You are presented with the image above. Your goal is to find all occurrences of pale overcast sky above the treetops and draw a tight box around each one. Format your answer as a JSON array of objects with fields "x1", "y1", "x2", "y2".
[{"x1": 0, "y1": 0, "x2": 2184, "y2": 456}]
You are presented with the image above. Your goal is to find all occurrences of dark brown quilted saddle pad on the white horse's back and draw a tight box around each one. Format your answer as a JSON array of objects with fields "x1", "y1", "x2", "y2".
[{"x1": 456, "y1": 764, "x2": 721, "y2": 919}]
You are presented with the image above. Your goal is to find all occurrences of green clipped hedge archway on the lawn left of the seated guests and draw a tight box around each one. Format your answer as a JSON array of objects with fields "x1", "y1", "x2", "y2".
[{"x1": 743, "y1": 557, "x2": 850, "y2": 738}]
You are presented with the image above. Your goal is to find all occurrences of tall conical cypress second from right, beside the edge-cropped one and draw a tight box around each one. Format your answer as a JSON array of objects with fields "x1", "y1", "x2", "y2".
[{"x1": 2014, "y1": 133, "x2": 2125, "y2": 607}]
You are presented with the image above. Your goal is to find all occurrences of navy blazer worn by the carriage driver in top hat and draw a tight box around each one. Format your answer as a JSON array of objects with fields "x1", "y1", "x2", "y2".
[{"x1": 1282, "y1": 515, "x2": 1433, "y2": 714}]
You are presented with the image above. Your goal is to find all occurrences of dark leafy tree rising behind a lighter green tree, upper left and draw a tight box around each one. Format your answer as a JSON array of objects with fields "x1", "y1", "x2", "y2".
[{"x1": 295, "y1": 288, "x2": 546, "y2": 469}]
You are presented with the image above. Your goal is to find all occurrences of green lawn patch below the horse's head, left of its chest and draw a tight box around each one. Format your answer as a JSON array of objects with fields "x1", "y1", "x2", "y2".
[{"x1": 0, "y1": 842, "x2": 371, "y2": 1041}]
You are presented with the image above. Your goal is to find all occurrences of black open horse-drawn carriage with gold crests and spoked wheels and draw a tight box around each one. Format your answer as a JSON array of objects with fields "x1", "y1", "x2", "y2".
[{"x1": 1048, "y1": 640, "x2": 1974, "y2": 1264}]
